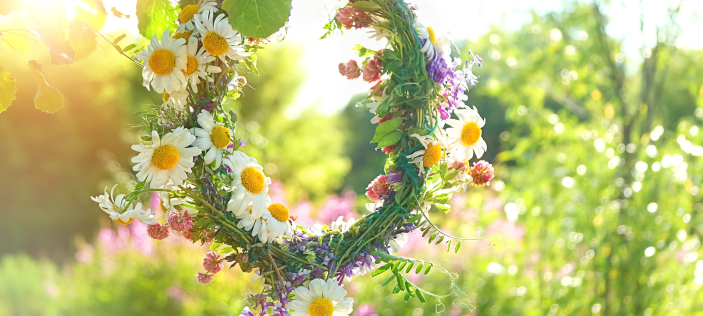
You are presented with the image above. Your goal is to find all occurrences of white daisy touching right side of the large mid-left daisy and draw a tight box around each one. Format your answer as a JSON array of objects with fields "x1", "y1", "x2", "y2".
[{"x1": 193, "y1": 110, "x2": 234, "y2": 169}]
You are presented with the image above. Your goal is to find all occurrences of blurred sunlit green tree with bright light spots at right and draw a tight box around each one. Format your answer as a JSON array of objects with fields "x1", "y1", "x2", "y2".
[{"x1": 452, "y1": 2, "x2": 703, "y2": 315}]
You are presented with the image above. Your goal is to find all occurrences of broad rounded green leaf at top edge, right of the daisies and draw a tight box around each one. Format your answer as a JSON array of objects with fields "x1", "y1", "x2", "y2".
[{"x1": 222, "y1": 0, "x2": 293, "y2": 38}]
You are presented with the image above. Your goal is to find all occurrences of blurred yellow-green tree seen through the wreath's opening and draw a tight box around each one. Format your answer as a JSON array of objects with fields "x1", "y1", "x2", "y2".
[{"x1": 225, "y1": 44, "x2": 350, "y2": 201}]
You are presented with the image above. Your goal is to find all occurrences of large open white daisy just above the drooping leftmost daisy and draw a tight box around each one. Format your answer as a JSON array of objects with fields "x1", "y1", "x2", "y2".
[{"x1": 132, "y1": 127, "x2": 201, "y2": 188}]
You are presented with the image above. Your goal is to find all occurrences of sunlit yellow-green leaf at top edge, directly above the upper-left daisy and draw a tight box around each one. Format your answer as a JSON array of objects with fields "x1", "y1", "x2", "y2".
[{"x1": 137, "y1": 0, "x2": 178, "y2": 39}]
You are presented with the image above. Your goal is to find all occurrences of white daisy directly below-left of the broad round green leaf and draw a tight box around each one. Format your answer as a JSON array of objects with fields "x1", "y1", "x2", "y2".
[{"x1": 194, "y1": 11, "x2": 250, "y2": 62}]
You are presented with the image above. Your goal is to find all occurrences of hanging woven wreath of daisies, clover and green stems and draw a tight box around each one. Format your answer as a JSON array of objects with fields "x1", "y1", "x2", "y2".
[{"x1": 93, "y1": 0, "x2": 500, "y2": 316}]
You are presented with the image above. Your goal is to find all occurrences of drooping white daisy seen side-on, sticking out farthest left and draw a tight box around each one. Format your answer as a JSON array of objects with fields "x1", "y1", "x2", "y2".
[{"x1": 90, "y1": 184, "x2": 158, "y2": 225}]
